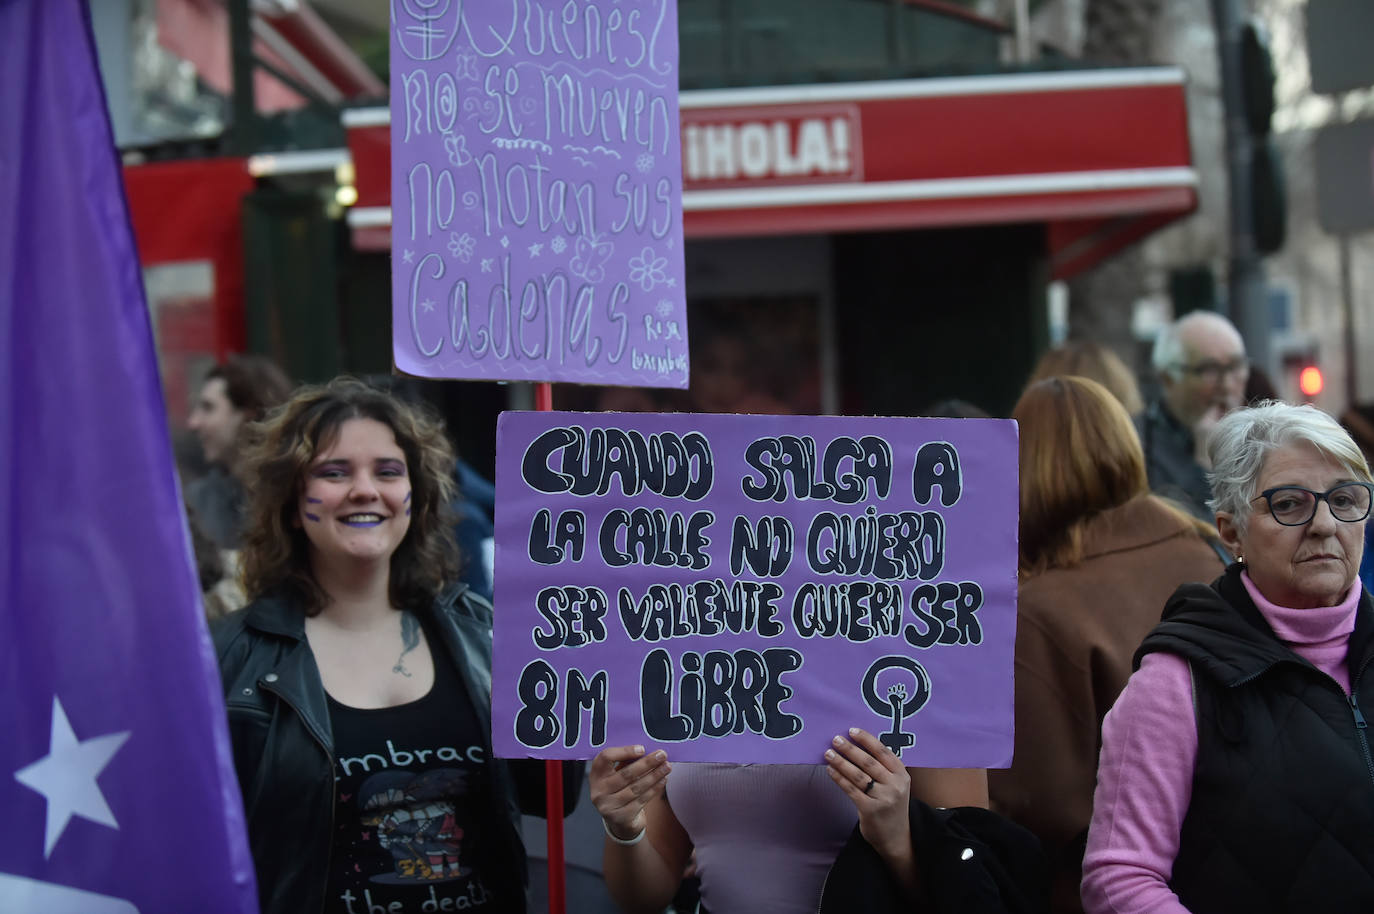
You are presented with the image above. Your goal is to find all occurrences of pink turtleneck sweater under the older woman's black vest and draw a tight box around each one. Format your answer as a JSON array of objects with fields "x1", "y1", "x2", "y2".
[{"x1": 1083, "y1": 575, "x2": 1360, "y2": 914}]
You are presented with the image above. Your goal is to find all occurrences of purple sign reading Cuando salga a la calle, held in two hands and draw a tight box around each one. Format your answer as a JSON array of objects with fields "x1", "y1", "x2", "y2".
[{"x1": 492, "y1": 412, "x2": 1017, "y2": 768}]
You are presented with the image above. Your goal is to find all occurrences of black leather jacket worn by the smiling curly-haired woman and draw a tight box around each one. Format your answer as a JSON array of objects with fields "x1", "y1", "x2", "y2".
[{"x1": 213, "y1": 584, "x2": 581, "y2": 914}]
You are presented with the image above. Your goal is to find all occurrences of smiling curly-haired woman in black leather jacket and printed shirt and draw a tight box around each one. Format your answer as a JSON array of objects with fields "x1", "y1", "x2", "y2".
[{"x1": 214, "y1": 378, "x2": 581, "y2": 914}]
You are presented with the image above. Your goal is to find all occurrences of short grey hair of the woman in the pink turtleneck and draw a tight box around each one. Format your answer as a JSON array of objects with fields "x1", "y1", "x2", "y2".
[{"x1": 1206, "y1": 400, "x2": 1374, "y2": 533}]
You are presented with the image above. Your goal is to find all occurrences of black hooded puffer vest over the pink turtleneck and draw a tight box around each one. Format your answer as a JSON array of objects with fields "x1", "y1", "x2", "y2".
[{"x1": 1136, "y1": 565, "x2": 1374, "y2": 914}]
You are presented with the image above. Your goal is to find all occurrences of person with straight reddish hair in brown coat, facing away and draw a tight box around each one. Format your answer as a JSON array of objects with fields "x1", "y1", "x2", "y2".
[{"x1": 988, "y1": 377, "x2": 1224, "y2": 913}]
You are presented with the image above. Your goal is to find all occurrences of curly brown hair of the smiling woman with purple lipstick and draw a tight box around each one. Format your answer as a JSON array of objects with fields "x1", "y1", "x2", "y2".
[{"x1": 242, "y1": 377, "x2": 459, "y2": 616}]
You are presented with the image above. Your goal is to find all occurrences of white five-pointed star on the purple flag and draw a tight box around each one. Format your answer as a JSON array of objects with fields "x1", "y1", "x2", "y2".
[{"x1": 14, "y1": 695, "x2": 131, "y2": 858}]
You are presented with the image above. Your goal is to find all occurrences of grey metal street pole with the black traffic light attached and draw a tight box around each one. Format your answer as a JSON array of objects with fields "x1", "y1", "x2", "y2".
[{"x1": 1212, "y1": 0, "x2": 1275, "y2": 374}]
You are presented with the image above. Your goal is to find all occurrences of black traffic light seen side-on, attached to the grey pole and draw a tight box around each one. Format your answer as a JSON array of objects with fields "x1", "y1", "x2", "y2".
[{"x1": 1241, "y1": 19, "x2": 1287, "y2": 254}]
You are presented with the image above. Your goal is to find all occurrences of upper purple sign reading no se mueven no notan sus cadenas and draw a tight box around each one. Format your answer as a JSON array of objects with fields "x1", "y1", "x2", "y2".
[{"x1": 392, "y1": 0, "x2": 688, "y2": 388}]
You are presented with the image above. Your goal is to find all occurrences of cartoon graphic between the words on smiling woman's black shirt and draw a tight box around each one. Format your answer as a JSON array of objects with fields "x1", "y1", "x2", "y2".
[{"x1": 357, "y1": 768, "x2": 473, "y2": 885}]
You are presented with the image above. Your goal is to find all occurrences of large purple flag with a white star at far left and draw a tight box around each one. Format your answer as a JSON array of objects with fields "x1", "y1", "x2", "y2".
[{"x1": 0, "y1": 0, "x2": 257, "y2": 914}]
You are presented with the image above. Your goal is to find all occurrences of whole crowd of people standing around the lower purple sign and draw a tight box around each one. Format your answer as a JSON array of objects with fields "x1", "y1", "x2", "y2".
[{"x1": 187, "y1": 306, "x2": 1374, "y2": 914}]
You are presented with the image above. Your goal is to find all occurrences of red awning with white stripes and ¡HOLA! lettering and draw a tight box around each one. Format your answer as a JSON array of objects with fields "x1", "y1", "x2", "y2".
[{"x1": 344, "y1": 67, "x2": 1197, "y2": 279}]
